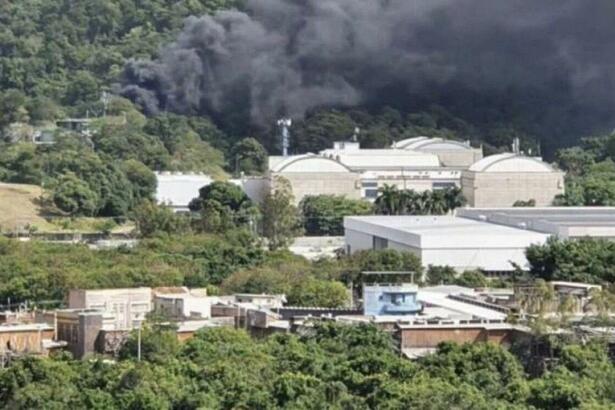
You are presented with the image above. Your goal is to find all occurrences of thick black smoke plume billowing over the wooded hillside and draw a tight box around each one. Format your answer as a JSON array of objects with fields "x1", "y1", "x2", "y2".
[{"x1": 123, "y1": 0, "x2": 615, "y2": 151}]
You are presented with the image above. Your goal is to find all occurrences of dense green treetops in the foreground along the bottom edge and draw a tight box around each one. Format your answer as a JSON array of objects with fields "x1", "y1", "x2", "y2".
[{"x1": 0, "y1": 323, "x2": 615, "y2": 410}]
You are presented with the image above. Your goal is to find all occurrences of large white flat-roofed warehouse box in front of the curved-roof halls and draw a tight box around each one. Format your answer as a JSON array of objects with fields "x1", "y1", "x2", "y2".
[{"x1": 344, "y1": 216, "x2": 549, "y2": 274}]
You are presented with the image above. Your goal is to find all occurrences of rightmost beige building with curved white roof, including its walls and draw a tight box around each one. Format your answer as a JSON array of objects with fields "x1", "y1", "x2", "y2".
[{"x1": 461, "y1": 153, "x2": 564, "y2": 208}]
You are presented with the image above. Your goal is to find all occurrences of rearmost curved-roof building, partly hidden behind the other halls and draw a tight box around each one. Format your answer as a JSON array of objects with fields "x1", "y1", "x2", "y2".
[{"x1": 392, "y1": 137, "x2": 483, "y2": 168}]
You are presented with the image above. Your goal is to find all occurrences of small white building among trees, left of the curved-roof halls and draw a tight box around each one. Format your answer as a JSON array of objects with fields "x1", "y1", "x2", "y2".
[{"x1": 156, "y1": 171, "x2": 213, "y2": 212}]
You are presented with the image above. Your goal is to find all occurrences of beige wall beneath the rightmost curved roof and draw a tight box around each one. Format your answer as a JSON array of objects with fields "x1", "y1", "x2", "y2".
[{"x1": 461, "y1": 171, "x2": 564, "y2": 208}]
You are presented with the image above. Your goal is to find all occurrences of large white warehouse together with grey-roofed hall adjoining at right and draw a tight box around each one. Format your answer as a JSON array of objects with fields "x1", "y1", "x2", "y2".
[{"x1": 344, "y1": 207, "x2": 615, "y2": 273}]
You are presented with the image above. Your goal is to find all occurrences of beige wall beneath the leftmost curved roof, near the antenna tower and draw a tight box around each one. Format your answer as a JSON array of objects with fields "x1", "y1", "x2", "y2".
[{"x1": 271, "y1": 172, "x2": 361, "y2": 204}]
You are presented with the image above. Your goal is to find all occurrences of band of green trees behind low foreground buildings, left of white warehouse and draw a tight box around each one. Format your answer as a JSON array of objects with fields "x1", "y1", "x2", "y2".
[{"x1": 0, "y1": 231, "x2": 434, "y2": 306}]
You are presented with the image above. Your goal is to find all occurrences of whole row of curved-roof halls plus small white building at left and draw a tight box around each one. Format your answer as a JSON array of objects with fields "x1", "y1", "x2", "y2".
[{"x1": 156, "y1": 137, "x2": 564, "y2": 211}]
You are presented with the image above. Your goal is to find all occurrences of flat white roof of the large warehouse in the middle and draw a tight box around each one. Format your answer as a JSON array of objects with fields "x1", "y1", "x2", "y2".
[{"x1": 344, "y1": 215, "x2": 548, "y2": 249}]
